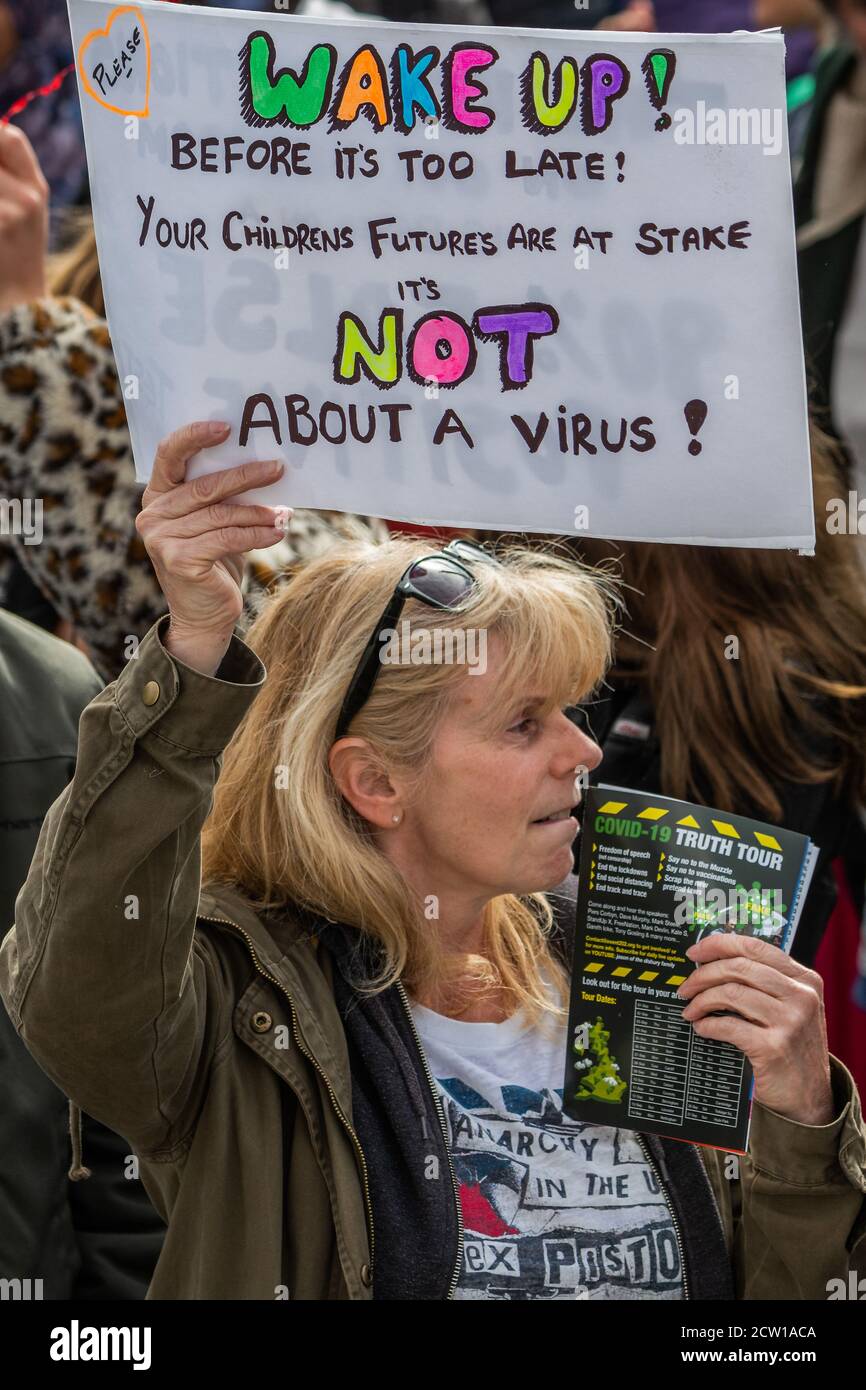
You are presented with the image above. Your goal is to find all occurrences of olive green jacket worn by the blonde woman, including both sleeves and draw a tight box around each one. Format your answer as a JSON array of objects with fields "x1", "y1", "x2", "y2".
[{"x1": 0, "y1": 619, "x2": 866, "y2": 1300}]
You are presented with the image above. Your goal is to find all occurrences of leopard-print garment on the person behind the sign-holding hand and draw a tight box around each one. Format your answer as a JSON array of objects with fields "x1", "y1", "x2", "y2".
[{"x1": 0, "y1": 299, "x2": 388, "y2": 680}]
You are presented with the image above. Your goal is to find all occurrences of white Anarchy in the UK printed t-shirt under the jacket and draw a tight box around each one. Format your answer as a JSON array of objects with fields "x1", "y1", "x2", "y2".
[{"x1": 411, "y1": 1002, "x2": 683, "y2": 1300}]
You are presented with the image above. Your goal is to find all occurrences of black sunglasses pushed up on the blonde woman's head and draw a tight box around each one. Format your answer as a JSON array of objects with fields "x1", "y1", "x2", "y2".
[{"x1": 334, "y1": 541, "x2": 502, "y2": 741}]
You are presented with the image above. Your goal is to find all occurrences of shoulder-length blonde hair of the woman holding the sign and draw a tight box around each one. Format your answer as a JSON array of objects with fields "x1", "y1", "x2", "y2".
[{"x1": 203, "y1": 538, "x2": 617, "y2": 1023}]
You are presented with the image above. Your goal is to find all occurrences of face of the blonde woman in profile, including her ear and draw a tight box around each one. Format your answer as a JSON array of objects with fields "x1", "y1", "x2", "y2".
[{"x1": 395, "y1": 637, "x2": 602, "y2": 904}]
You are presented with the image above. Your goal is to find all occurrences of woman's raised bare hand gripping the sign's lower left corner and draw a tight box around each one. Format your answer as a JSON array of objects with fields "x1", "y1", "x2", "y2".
[{"x1": 136, "y1": 421, "x2": 291, "y2": 676}]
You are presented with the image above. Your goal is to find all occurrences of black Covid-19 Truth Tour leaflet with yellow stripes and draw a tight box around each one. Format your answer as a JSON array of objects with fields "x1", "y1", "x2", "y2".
[{"x1": 563, "y1": 785, "x2": 817, "y2": 1152}]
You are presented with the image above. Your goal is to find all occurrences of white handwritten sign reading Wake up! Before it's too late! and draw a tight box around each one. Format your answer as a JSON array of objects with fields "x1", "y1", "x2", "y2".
[{"x1": 70, "y1": 0, "x2": 815, "y2": 548}]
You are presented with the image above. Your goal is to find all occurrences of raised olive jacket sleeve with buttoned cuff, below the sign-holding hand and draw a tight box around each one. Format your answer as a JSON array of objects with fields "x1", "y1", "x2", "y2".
[{"x1": 0, "y1": 619, "x2": 264, "y2": 1159}]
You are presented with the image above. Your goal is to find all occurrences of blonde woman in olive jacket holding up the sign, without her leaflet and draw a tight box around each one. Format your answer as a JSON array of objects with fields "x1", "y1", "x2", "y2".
[{"x1": 0, "y1": 424, "x2": 866, "y2": 1300}]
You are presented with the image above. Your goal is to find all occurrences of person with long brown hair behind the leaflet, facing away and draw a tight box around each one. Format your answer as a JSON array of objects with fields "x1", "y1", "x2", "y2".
[{"x1": 571, "y1": 427, "x2": 866, "y2": 965}]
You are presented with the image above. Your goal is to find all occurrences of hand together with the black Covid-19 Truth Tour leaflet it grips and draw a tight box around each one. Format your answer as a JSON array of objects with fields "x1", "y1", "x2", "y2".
[{"x1": 563, "y1": 787, "x2": 833, "y2": 1152}]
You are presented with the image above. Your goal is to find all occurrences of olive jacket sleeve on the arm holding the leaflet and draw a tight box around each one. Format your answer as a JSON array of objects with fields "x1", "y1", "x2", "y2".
[{"x1": 721, "y1": 1055, "x2": 866, "y2": 1301}]
